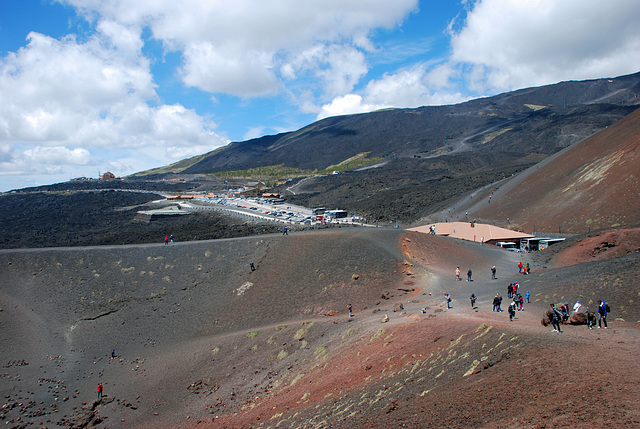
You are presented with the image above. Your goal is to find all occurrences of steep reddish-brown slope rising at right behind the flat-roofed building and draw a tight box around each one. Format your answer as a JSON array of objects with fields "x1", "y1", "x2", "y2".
[{"x1": 456, "y1": 106, "x2": 640, "y2": 234}]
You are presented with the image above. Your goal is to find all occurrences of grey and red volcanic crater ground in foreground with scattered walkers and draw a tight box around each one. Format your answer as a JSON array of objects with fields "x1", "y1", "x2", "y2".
[{"x1": 0, "y1": 228, "x2": 640, "y2": 428}]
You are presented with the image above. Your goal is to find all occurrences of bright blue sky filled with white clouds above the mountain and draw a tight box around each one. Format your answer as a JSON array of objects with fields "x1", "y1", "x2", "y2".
[{"x1": 0, "y1": 0, "x2": 640, "y2": 191}]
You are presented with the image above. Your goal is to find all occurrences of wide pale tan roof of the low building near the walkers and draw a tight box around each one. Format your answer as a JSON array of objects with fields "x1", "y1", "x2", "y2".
[{"x1": 409, "y1": 222, "x2": 534, "y2": 243}]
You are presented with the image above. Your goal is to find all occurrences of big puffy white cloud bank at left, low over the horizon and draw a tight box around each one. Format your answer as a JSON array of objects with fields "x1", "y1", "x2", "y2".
[{"x1": 0, "y1": 21, "x2": 228, "y2": 187}]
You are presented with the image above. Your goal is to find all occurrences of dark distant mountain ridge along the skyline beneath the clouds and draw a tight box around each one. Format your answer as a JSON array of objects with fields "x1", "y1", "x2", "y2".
[{"x1": 146, "y1": 73, "x2": 640, "y2": 174}]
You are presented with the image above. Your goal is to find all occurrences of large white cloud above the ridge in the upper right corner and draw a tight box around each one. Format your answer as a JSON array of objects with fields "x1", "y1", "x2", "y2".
[{"x1": 451, "y1": 0, "x2": 640, "y2": 92}]
